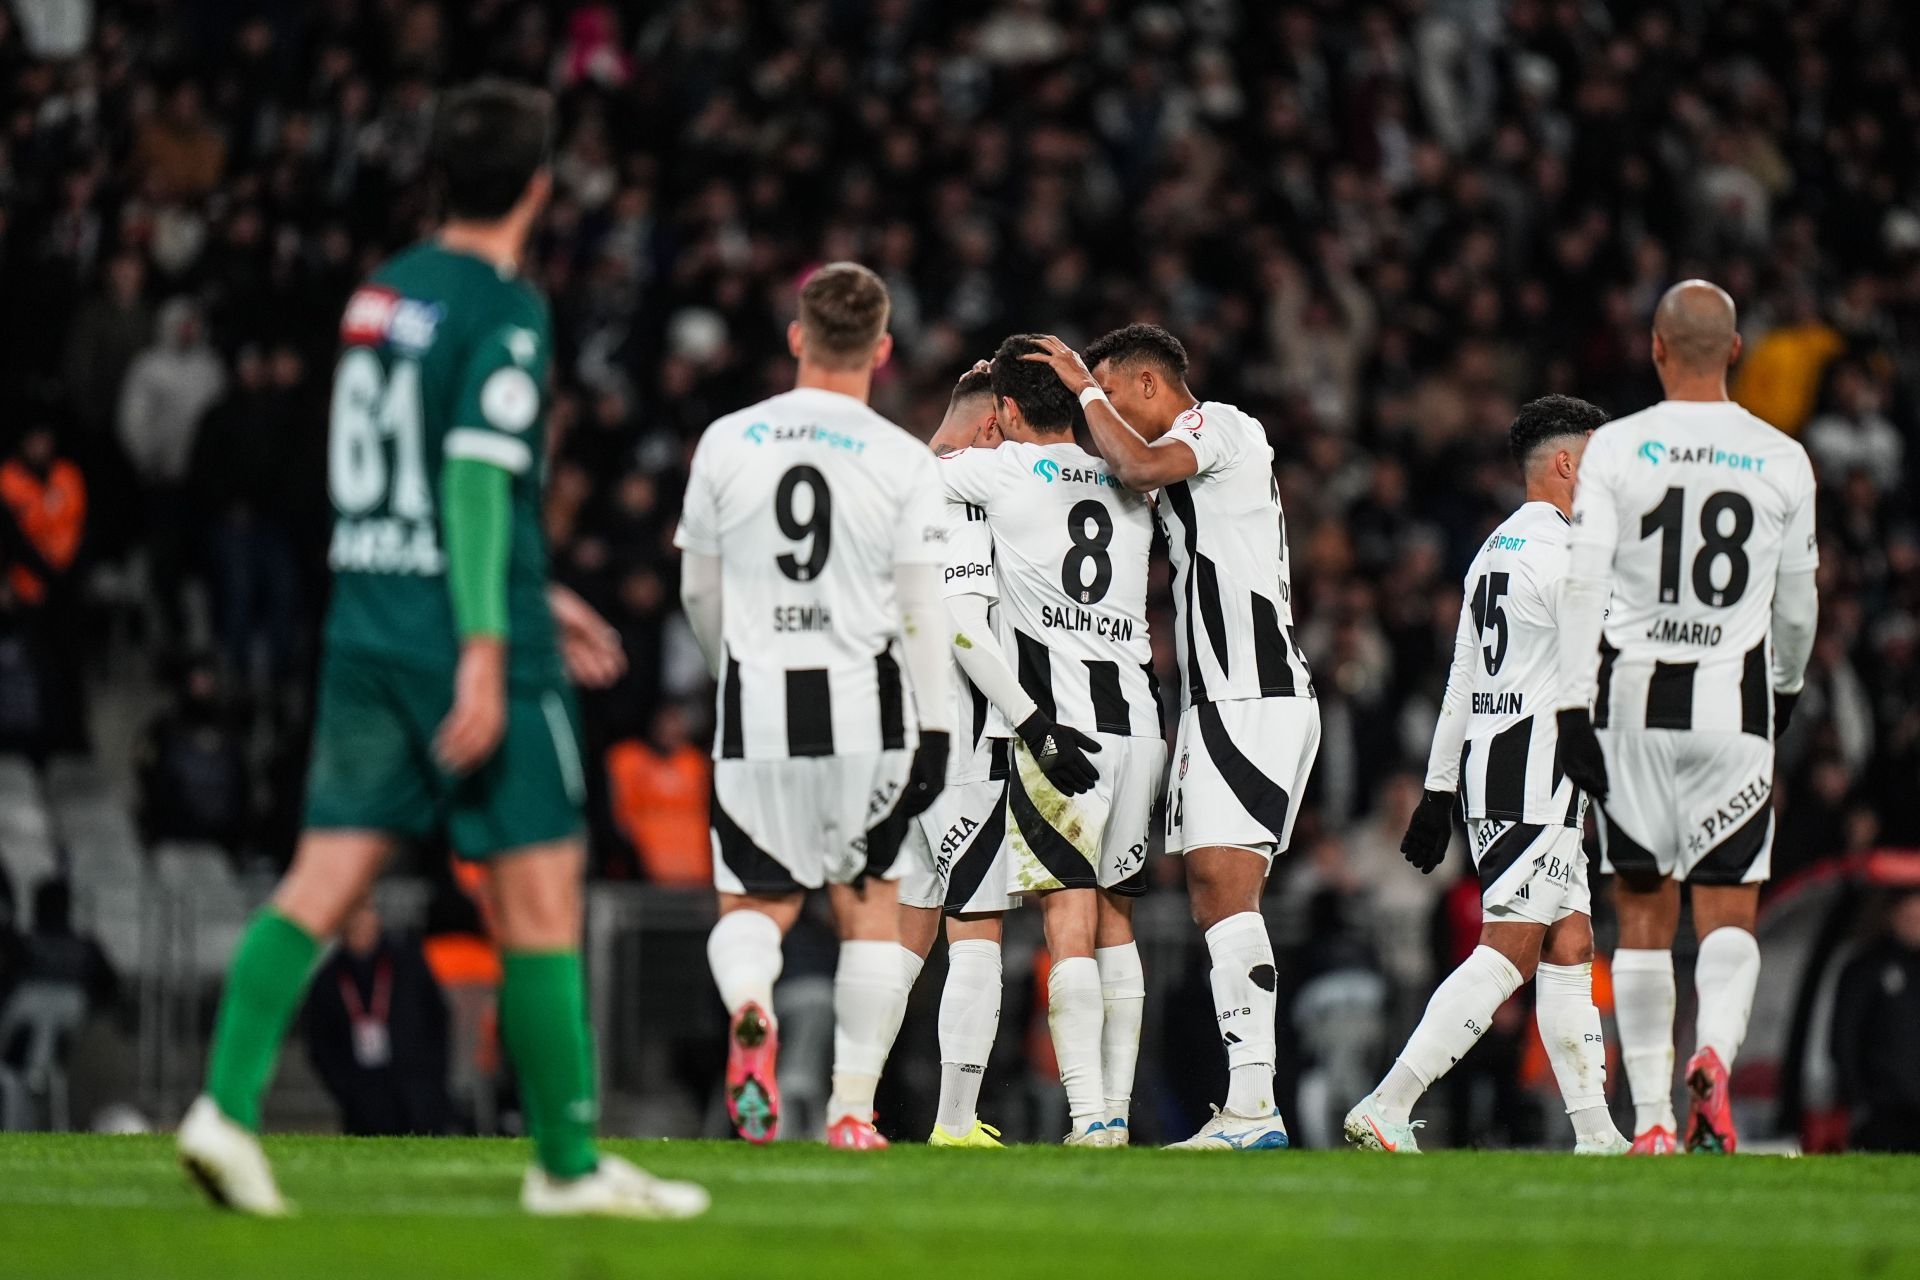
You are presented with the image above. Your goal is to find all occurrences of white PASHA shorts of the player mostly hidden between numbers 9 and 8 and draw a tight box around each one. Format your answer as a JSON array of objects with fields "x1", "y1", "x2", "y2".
[{"x1": 897, "y1": 739, "x2": 1020, "y2": 915}]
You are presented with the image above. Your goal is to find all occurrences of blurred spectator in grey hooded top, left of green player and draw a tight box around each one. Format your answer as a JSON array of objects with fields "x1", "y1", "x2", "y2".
[{"x1": 119, "y1": 297, "x2": 227, "y2": 643}]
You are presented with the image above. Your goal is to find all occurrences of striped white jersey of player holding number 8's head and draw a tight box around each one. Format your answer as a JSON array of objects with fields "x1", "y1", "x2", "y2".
[{"x1": 1160, "y1": 401, "x2": 1313, "y2": 706}]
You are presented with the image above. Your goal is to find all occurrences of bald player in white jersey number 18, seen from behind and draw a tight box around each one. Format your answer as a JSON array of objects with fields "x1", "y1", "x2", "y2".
[{"x1": 1559, "y1": 280, "x2": 1820, "y2": 1153}]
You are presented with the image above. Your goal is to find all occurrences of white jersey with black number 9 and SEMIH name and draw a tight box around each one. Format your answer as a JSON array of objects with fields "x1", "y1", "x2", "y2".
[{"x1": 674, "y1": 388, "x2": 948, "y2": 760}]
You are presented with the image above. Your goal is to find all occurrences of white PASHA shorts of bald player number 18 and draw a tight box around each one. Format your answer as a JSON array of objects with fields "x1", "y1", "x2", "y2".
[{"x1": 1599, "y1": 729, "x2": 1774, "y2": 885}]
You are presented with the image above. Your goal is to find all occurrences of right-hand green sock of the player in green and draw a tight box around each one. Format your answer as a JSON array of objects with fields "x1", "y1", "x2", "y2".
[{"x1": 499, "y1": 952, "x2": 599, "y2": 1178}]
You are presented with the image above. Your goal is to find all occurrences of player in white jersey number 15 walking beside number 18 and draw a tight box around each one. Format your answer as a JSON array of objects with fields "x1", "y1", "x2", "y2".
[{"x1": 1344, "y1": 395, "x2": 1626, "y2": 1155}]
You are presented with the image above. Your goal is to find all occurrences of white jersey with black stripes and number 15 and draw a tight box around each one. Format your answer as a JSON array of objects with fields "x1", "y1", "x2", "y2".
[{"x1": 1427, "y1": 503, "x2": 1582, "y2": 827}]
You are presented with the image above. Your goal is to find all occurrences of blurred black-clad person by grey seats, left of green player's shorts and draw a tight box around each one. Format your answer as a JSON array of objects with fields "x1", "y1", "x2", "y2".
[{"x1": 134, "y1": 658, "x2": 255, "y2": 856}]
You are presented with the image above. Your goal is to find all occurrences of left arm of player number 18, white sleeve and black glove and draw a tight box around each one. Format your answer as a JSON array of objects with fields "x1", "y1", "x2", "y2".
[{"x1": 1555, "y1": 445, "x2": 1620, "y2": 800}]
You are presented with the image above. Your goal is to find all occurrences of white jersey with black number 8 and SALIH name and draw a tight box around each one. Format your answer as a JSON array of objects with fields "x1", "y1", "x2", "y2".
[{"x1": 939, "y1": 441, "x2": 1162, "y2": 737}]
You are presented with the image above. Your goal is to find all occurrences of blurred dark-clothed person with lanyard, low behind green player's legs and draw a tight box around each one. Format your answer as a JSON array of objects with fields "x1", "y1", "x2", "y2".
[{"x1": 305, "y1": 902, "x2": 453, "y2": 1138}]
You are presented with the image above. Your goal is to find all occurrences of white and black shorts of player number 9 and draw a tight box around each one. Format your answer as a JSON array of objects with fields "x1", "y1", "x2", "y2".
[{"x1": 712, "y1": 750, "x2": 914, "y2": 894}]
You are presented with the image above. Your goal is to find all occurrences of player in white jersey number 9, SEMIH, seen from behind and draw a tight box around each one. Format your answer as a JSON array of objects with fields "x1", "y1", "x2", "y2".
[{"x1": 674, "y1": 263, "x2": 952, "y2": 1148}]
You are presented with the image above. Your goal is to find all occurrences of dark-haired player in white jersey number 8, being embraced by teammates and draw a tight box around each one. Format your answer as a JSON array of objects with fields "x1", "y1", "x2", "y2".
[{"x1": 941, "y1": 334, "x2": 1165, "y2": 1146}]
